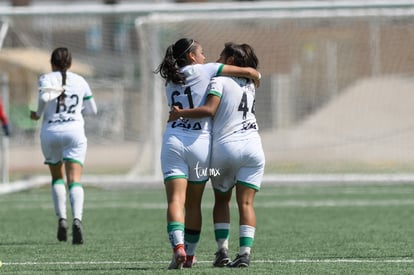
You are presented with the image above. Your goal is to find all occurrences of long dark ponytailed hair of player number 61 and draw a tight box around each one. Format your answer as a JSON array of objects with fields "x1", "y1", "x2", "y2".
[{"x1": 154, "y1": 38, "x2": 200, "y2": 84}]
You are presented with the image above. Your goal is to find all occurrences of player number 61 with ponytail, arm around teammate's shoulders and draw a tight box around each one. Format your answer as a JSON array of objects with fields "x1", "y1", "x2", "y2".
[{"x1": 154, "y1": 38, "x2": 260, "y2": 269}]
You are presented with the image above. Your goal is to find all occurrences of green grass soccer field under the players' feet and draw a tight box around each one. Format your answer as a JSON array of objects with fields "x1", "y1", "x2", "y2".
[{"x1": 0, "y1": 183, "x2": 414, "y2": 274}]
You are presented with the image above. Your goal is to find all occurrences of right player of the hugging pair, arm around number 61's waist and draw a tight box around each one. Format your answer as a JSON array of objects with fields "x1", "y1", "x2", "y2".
[{"x1": 169, "y1": 43, "x2": 265, "y2": 267}]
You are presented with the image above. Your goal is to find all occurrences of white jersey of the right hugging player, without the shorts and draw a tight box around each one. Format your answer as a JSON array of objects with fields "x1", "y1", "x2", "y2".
[{"x1": 208, "y1": 76, "x2": 258, "y2": 142}]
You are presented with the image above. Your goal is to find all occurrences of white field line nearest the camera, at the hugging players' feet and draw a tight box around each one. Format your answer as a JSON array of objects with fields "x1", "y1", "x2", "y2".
[{"x1": 3, "y1": 258, "x2": 414, "y2": 266}]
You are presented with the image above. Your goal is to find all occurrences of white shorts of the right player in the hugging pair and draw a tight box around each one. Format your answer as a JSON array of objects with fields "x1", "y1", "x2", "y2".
[{"x1": 210, "y1": 135, "x2": 265, "y2": 192}]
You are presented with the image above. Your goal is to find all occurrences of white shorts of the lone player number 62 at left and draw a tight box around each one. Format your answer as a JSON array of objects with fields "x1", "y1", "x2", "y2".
[{"x1": 40, "y1": 131, "x2": 87, "y2": 165}]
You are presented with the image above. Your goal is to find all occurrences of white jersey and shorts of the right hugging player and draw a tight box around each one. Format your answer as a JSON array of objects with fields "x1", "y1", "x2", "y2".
[{"x1": 209, "y1": 77, "x2": 265, "y2": 192}]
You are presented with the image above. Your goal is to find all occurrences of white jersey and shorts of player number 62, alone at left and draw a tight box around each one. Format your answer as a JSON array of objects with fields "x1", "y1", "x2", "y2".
[{"x1": 36, "y1": 72, "x2": 97, "y2": 165}]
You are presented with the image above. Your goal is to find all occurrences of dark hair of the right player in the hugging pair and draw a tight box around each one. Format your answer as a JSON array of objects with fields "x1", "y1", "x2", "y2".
[{"x1": 222, "y1": 42, "x2": 259, "y2": 69}]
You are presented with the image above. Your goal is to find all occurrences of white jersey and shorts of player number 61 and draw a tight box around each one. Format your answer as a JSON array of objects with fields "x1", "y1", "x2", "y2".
[{"x1": 161, "y1": 63, "x2": 223, "y2": 183}]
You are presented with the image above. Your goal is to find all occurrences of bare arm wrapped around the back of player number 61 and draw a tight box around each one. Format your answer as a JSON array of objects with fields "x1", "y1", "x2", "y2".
[{"x1": 168, "y1": 94, "x2": 220, "y2": 121}]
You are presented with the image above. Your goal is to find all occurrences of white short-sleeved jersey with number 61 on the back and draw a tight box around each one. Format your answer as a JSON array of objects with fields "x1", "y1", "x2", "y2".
[{"x1": 166, "y1": 63, "x2": 224, "y2": 135}]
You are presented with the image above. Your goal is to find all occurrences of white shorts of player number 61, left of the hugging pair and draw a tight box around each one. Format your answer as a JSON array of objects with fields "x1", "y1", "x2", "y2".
[{"x1": 161, "y1": 134, "x2": 210, "y2": 183}]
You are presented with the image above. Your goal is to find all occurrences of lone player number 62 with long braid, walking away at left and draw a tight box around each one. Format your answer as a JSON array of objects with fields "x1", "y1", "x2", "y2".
[{"x1": 30, "y1": 47, "x2": 97, "y2": 244}]
